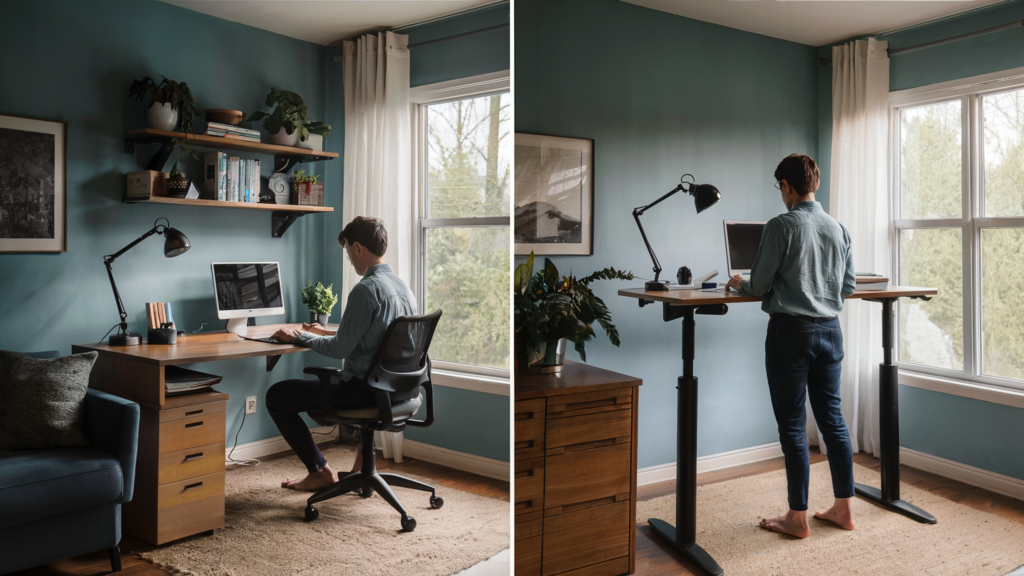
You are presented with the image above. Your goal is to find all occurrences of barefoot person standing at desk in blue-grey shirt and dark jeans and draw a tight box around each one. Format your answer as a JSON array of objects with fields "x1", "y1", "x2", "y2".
[{"x1": 727, "y1": 154, "x2": 856, "y2": 538}]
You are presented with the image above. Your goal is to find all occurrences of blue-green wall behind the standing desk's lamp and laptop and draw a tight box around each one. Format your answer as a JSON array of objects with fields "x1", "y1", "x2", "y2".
[{"x1": 515, "y1": 0, "x2": 818, "y2": 467}]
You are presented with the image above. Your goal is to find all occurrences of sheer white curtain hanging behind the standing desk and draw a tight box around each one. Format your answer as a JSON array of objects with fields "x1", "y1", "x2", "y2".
[{"x1": 808, "y1": 39, "x2": 895, "y2": 457}]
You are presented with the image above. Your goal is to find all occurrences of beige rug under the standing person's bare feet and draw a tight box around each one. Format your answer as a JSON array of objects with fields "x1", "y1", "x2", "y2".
[{"x1": 637, "y1": 462, "x2": 1024, "y2": 576}]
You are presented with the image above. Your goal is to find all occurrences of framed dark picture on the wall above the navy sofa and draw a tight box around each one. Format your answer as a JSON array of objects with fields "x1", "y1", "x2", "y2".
[{"x1": 0, "y1": 114, "x2": 68, "y2": 253}]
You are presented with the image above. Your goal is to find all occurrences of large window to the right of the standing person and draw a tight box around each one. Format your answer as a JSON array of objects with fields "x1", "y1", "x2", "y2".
[{"x1": 890, "y1": 71, "x2": 1024, "y2": 388}]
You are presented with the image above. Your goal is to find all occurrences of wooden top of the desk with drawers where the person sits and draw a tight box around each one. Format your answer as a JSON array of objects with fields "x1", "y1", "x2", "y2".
[{"x1": 73, "y1": 324, "x2": 321, "y2": 366}]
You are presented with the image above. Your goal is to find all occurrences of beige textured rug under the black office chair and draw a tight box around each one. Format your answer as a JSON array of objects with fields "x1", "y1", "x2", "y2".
[{"x1": 140, "y1": 447, "x2": 510, "y2": 576}]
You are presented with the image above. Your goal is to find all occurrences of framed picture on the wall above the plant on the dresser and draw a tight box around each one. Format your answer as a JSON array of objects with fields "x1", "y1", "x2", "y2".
[{"x1": 514, "y1": 132, "x2": 594, "y2": 256}]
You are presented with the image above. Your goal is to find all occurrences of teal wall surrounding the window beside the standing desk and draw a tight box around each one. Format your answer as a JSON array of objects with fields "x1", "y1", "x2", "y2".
[{"x1": 818, "y1": 0, "x2": 1024, "y2": 480}]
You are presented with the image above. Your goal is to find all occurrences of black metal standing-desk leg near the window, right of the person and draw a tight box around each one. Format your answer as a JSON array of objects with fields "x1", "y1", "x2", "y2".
[{"x1": 854, "y1": 298, "x2": 938, "y2": 524}]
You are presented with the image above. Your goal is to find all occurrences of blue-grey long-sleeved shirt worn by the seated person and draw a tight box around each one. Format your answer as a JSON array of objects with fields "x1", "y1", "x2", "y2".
[{"x1": 295, "y1": 264, "x2": 417, "y2": 382}]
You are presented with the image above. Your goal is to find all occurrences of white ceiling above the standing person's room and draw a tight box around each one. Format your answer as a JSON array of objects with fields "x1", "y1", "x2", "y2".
[{"x1": 624, "y1": 0, "x2": 1004, "y2": 46}]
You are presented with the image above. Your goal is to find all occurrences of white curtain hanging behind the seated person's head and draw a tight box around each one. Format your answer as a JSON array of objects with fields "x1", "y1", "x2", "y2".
[{"x1": 340, "y1": 32, "x2": 416, "y2": 462}]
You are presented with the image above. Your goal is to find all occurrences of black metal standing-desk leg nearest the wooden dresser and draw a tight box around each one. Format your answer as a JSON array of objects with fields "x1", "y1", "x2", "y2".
[{"x1": 647, "y1": 306, "x2": 724, "y2": 576}]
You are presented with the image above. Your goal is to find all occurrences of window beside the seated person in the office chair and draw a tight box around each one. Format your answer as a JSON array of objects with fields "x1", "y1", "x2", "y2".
[{"x1": 413, "y1": 73, "x2": 512, "y2": 377}]
